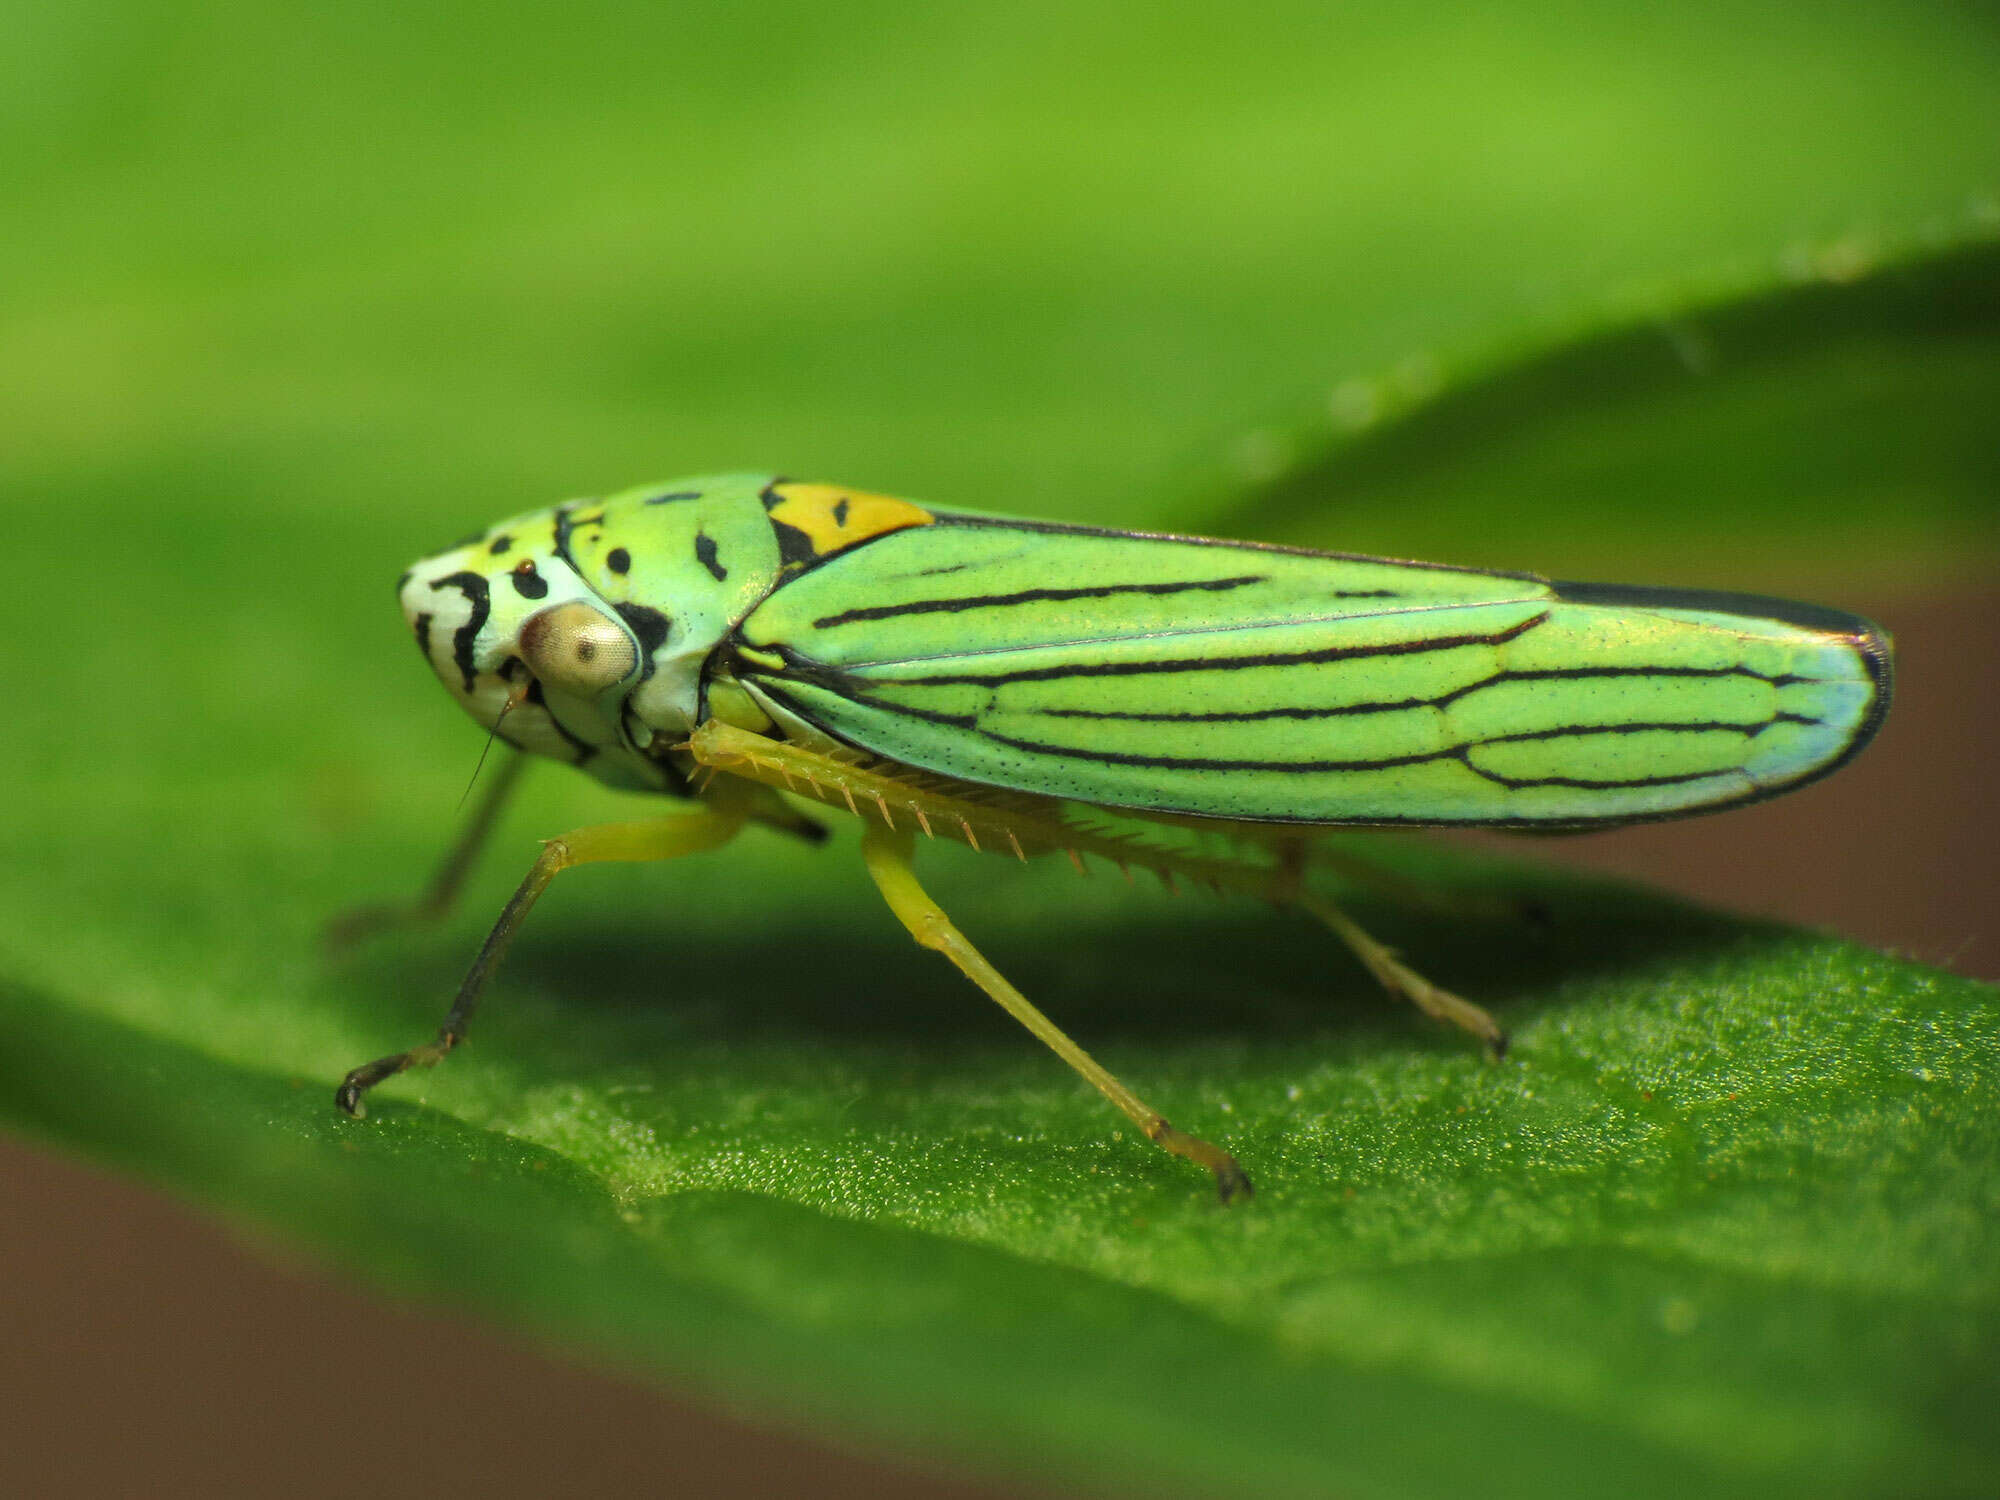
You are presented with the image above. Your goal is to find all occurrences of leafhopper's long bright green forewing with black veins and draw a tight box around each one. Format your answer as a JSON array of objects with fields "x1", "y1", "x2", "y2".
[{"x1": 736, "y1": 512, "x2": 1888, "y2": 826}]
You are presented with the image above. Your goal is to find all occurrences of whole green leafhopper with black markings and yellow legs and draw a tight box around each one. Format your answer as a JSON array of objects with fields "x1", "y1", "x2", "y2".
[{"x1": 336, "y1": 474, "x2": 1890, "y2": 1200}]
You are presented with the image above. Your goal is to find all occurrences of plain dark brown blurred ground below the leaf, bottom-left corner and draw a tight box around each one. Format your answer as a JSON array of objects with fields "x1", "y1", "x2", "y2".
[{"x1": 0, "y1": 1138, "x2": 1024, "y2": 1500}]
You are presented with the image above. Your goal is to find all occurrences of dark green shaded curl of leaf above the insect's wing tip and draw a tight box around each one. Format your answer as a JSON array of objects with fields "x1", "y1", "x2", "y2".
[{"x1": 1190, "y1": 234, "x2": 2000, "y2": 592}]
